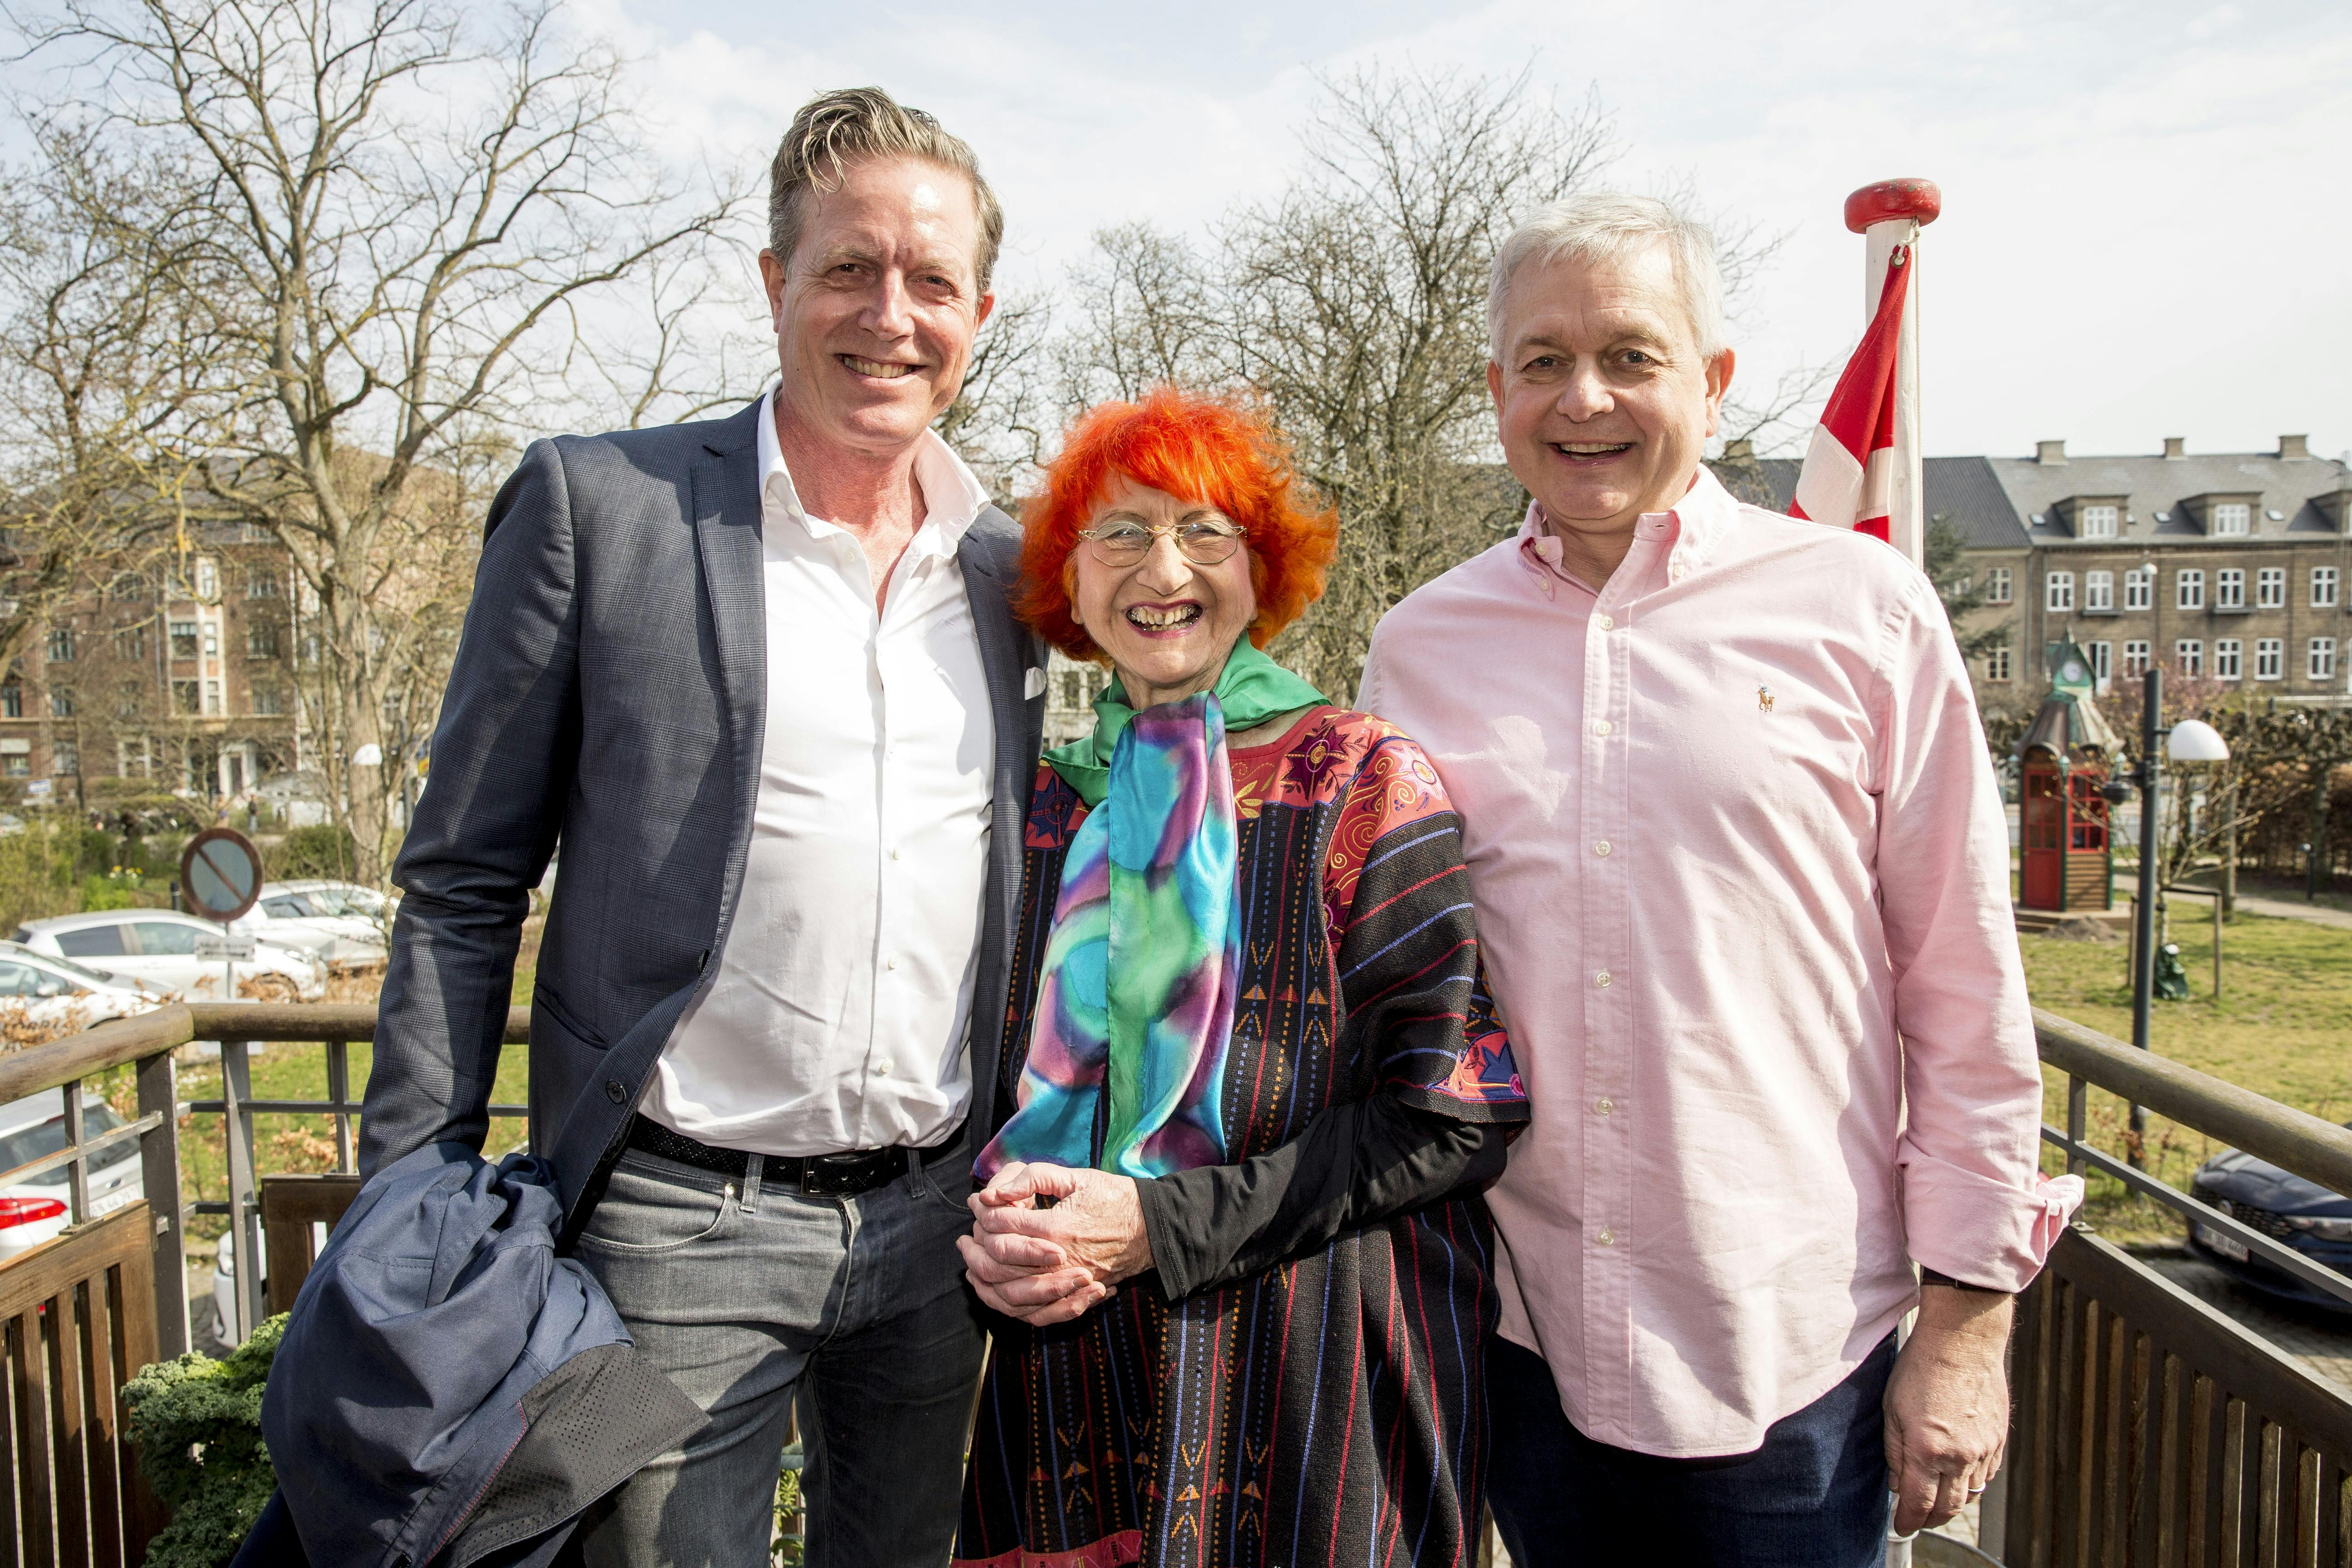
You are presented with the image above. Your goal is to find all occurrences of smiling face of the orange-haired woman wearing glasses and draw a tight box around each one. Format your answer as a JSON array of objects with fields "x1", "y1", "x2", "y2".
[{"x1": 1070, "y1": 475, "x2": 1258, "y2": 710}]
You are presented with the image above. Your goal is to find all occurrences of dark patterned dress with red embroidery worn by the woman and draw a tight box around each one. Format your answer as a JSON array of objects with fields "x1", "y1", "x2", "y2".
[{"x1": 957, "y1": 708, "x2": 1526, "y2": 1568}]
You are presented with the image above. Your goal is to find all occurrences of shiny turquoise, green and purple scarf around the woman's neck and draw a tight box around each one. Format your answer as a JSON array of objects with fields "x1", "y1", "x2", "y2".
[{"x1": 979, "y1": 642, "x2": 1322, "y2": 1180}]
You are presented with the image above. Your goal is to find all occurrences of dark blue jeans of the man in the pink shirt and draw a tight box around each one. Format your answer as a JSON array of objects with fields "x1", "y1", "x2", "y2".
[{"x1": 1486, "y1": 1335, "x2": 1896, "y2": 1568}]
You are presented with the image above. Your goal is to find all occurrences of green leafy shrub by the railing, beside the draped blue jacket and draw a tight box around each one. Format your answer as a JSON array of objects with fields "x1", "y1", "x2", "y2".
[{"x1": 122, "y1": 1314, "x2": 287, "y2": 1568}]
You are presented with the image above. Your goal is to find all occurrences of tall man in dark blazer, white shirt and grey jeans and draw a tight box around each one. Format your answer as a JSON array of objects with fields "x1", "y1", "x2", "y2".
[{"x1": 360, "y1": 89, "x2": 1044, "y2": 1568}]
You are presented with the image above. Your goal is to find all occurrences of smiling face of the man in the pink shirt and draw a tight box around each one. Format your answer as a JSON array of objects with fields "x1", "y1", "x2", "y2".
[{"x1": 1486, "y1": 245, "x2": 1731, "y2": 576}]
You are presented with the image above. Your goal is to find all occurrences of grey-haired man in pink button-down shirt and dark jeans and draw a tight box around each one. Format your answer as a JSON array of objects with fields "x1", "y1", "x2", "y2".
[{"x1": 1362, "y1": 195, "x2": 2079, "y2": 1568}]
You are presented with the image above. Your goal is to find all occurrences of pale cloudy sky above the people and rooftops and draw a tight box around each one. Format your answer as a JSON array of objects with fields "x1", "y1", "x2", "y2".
[{"x1": 593, "y1": 0, "x2": 2352, "y2": 456}]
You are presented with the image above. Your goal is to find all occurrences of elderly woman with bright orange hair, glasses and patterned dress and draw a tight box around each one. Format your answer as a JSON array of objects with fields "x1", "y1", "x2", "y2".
[{"x1": 957, "y1": 390, "x2": 1526, "y2": 1568}]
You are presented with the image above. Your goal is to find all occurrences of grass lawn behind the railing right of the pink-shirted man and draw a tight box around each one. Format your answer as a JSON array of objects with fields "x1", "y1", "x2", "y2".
[{"x1": 2018, "y1": 900, "x2": 2352, "y2": 1241}]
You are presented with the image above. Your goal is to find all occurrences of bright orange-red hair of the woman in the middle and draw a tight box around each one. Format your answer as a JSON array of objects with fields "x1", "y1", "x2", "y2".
[{"x1": 1014, "y1": 386, "x2": 1338, "y2": 658}]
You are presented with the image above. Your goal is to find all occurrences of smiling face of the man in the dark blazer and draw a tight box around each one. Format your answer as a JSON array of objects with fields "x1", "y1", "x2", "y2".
[{"x1": 760, "y1": 157, "x2": 995, "y2": 451}]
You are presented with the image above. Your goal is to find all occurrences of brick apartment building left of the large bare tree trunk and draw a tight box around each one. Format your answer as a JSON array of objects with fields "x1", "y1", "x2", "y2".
[{"x1": 0, "y1": 527, "x2": 304, "y2": 802}]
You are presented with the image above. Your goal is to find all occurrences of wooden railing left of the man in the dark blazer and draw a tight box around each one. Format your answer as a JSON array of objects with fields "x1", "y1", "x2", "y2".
[{"x1": 0, "y1": 1001, "x2": 529, "y2": 1568}]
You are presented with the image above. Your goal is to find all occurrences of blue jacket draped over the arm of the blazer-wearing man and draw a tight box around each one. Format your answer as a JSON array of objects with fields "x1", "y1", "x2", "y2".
[{"x1": 233, "y1": 1142, "x2": 703, "y2": 1568}]
